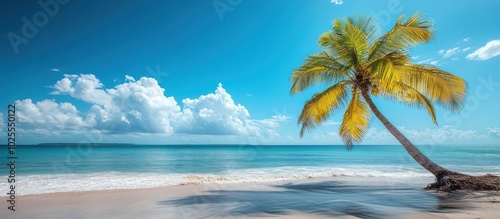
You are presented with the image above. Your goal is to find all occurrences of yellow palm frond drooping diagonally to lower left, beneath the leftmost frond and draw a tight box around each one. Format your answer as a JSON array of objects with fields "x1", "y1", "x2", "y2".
[{"x1": 298, "y1": 81, "x2": 349, "y2": 137}]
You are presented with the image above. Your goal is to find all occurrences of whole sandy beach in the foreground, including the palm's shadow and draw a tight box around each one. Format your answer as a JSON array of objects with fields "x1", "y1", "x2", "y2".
[{"x1": 0, "y1": 177, "x2": 500, "y2": 218}]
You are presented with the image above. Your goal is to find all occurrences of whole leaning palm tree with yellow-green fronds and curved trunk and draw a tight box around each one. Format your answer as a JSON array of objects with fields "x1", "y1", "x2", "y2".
[{"x1": 290, "y1": 12, "x2": 500, "y2": 190}]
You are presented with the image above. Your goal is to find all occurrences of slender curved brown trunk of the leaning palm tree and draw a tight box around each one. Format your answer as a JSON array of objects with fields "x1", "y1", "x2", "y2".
[{"x1": 361, "y1": 89, "x2": 450, "y2": 178}]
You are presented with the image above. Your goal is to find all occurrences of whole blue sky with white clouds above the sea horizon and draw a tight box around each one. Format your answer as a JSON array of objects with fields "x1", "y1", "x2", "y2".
[{"x1": 0, "y1": 0, "x2": 500, "y2": 145}]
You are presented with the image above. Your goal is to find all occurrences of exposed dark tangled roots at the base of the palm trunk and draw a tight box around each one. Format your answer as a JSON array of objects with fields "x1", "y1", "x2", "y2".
[{"x1": 426, "y1": 171, "x2": 500, "y2": 192}]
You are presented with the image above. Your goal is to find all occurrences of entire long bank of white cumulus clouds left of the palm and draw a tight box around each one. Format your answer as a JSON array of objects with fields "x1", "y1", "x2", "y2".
[{"x1": 17, "y1": 74, "x2": 278, "y2": 136}]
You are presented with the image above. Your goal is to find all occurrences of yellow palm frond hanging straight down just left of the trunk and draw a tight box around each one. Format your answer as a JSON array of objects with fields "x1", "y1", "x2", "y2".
[{"x1": 339, "y1": 90, "x2": 371, "y2": 148}]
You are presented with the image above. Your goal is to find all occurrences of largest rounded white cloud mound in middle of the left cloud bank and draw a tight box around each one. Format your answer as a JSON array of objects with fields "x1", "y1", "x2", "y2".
[{"x1": 95, "y1": 77, "x2": 181, "y2": 134}]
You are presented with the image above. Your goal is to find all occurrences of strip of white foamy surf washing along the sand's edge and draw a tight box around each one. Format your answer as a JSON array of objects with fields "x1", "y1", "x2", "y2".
[{"x1": 0, "y1": 165, "x2": 496, "y2": 196}]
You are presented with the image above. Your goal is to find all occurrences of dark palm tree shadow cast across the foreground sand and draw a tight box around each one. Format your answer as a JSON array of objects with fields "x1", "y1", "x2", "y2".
[{"x1": 159, "y1": 181, "x2": 478, "y2": 218}]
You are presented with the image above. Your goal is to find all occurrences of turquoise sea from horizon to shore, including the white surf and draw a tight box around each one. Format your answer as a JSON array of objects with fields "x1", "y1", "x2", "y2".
[{"x1": 0, "y1": 145, "x2": 500, "y2": 196}]
